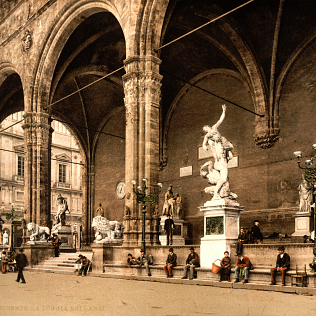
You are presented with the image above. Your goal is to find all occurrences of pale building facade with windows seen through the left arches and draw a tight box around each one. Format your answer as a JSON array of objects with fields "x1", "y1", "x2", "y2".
[{"x1": 0, "y1": 112, "x2": 82, "y2": 246}]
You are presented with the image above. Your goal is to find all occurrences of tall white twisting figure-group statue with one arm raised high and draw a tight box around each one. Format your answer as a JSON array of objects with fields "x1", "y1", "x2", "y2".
[{"x1": 200, "y1": 104, "x2": 236, "y2": 200}]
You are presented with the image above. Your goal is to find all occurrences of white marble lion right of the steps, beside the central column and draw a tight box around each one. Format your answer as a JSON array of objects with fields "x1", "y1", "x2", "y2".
[{"x1": 92, "y1": 216, "x2": 122, "y2": 243}]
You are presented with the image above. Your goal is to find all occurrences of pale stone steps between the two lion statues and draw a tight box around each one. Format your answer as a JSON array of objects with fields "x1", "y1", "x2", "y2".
[{"x1": 25, "y1": 252, "x2": 92, "y2": 274}]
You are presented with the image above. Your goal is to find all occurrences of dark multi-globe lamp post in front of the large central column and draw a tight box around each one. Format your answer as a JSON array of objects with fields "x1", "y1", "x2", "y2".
[{"x1": 131, "y1": 178, "x2": 162, "y2": 251}]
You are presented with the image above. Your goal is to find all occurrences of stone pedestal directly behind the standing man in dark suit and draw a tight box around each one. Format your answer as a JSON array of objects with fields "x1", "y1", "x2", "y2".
[{"x1": 159, "y1": 216, "x2": 188, "y2": 246}]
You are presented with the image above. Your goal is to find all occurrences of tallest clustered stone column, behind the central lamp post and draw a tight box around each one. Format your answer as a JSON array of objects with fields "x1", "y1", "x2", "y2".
[{"x1": 123, "y1": 56, "x2": 162, "y2": 245}]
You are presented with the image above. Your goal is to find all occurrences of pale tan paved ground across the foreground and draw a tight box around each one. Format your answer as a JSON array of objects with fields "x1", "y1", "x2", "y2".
[{"x1": 0, "y1": 271, "x2": 316, "y2": 316}]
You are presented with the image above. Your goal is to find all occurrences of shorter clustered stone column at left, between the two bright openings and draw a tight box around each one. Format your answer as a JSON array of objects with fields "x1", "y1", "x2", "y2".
[{"x1": 22, "y1": 112, "x2": 53, "y2": 239}]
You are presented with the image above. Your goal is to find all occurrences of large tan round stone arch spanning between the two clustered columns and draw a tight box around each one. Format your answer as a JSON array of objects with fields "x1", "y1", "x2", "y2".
[{"x1": 34, "y1": 0, "x2": 124, "y2": 111}]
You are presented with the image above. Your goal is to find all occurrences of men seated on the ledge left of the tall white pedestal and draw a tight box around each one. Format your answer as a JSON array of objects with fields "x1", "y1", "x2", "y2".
[{"x1": 127, "y1": 247, "x2": 200, "y2": 280}]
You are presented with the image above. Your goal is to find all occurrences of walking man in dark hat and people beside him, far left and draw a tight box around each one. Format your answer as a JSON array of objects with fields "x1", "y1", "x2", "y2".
[{"x1": 1, "y1": 248, "x2": 27, "y2": 283}]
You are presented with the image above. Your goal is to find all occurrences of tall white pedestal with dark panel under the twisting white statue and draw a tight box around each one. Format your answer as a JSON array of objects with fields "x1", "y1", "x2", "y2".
[{"x1": 199, "y1": 199, "x2": 244, "y2": 268}]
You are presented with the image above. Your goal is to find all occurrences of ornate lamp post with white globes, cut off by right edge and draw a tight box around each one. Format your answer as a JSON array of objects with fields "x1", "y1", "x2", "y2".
[{"x1": 293, "y1": 144, "x2": 316, "y2": 272}]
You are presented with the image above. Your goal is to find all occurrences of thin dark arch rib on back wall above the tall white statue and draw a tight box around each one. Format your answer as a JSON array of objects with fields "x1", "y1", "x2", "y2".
[{"x1": 160, "y1": 69, "x2": 249, "y2": 167}]
